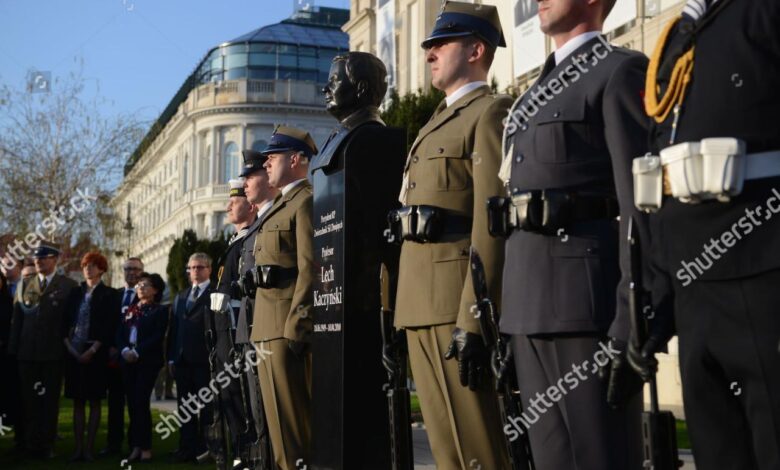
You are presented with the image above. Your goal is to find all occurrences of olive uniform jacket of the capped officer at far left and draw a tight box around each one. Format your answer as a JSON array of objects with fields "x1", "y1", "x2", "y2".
[{"x1": 8, "y1": 274, "x2": 81, "y2": 361}]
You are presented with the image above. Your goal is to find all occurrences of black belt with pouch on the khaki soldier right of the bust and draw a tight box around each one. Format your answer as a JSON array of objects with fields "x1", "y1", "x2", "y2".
[{"x1": 387, "y1": 205, "x2": 472, "y2": 243}]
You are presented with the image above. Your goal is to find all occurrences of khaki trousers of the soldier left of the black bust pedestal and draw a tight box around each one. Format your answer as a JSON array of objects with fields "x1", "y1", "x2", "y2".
[{"x1": 257, "y1": 338, "x2": 311, "y2": 470}]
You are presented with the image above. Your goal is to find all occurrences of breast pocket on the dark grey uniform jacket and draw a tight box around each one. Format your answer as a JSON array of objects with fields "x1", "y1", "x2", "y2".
[{"x1": 533, "y1": 102, "x2": 588, "y2": 163}]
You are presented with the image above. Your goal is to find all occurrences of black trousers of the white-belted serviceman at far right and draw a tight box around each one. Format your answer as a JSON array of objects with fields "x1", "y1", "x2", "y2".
[{"x1": 675, "y1": 270, "x2": 780, "y2": 470}]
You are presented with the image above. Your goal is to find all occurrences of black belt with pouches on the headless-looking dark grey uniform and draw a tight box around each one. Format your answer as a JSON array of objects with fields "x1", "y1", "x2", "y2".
[{"x1": 488, "y1": 189, "x2": 620, "y2": 237}]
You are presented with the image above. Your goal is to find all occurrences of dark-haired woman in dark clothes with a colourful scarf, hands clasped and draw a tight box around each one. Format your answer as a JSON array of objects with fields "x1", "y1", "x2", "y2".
[{"x1": 116, "y1": 273, "x2": 168, "y2": 462}]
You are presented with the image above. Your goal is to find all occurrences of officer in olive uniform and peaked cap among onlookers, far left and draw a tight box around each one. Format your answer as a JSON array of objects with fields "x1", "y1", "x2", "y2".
[{"x1": 8, "y1": 244, "x2": 80, "y2": 458}]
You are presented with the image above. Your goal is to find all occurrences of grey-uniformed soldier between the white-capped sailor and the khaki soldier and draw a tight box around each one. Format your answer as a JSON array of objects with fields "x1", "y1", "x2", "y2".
[{"x1": 236, "y1": 150, "x2": 278, "y2": 469}]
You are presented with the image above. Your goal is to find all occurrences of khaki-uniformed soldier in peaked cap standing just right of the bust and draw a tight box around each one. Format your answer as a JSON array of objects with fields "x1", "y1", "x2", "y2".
[{"x1": 395, "y1": 2, "x2": 511, "y2": 469}]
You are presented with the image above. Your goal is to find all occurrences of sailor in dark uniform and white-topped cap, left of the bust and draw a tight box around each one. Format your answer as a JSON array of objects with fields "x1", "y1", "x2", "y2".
[{"x1": 207, "y1": 178, "x2": 257, "y2": 468}]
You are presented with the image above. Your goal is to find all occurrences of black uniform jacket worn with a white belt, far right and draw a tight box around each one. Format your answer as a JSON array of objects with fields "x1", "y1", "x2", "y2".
[{"x1": 651, "y1": 0, "x2": 780, "y2": 294}]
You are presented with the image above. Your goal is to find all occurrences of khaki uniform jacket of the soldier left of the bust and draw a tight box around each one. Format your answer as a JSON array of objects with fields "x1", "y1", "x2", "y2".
[{"x1": 251, "y1": 180, "x2": 314, "y2": 342}]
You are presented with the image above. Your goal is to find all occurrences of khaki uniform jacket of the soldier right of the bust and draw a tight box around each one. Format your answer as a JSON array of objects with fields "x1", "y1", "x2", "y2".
[{"x1": 395, "y1": 86, "x2": 511, "y2": 333}]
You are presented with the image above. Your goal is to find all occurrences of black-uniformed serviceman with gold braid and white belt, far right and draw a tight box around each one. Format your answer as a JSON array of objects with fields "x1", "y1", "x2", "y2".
[{"x1": 629, "y1": 0, "x2": 780, "y2": 470}]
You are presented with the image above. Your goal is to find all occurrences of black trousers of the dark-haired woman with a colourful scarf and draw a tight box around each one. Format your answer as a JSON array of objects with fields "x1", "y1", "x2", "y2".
[{"x1": 122, "y1": 364, "x2": 160, "y2": 449}]
